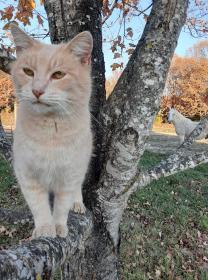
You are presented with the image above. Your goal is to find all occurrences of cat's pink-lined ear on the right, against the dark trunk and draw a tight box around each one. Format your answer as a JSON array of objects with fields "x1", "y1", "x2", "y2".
[{"x1": 67, "y1": 31, "x2": 93, "y2": 64}]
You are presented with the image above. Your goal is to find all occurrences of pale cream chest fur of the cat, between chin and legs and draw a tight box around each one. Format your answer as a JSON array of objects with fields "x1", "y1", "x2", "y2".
[{"x1": 14, "y1": 112, "x2": 92, "y2": 189}]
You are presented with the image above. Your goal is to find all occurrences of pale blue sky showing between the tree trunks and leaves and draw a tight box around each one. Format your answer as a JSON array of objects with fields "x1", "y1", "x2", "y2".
[{"x1": 0, "y1": 0, "x2": 206, "y2": 78}]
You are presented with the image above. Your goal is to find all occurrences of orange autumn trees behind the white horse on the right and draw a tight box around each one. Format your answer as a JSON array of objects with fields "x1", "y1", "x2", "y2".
[{"x1": 161, "y1": 53, "x2": 208, "y2": 120}]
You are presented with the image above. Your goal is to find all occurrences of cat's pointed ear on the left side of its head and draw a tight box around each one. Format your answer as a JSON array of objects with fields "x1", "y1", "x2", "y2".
[{"x1": 10, "y1": 23, "x2": 38, "y2": 55}]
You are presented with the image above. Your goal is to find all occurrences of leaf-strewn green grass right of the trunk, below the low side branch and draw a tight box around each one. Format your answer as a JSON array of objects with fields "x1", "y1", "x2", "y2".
[{"x1": 120, "y1": 152, "x2": 208, "y2": 280}]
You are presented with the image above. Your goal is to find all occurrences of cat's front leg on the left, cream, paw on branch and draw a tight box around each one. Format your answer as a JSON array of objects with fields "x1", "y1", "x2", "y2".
[{"x1": 21, "y1": 184, "x2": 56, "y2": 238}]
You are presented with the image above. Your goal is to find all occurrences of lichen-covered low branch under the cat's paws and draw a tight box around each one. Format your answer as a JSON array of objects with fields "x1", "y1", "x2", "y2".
[{"x1": 0, "y1": 213, "x2": 92, "y2": 280}]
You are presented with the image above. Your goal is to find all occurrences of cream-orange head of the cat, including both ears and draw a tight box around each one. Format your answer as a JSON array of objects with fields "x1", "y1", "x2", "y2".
[{"x1": 11, "y1": 25, "x2": 93, "y2": 115}]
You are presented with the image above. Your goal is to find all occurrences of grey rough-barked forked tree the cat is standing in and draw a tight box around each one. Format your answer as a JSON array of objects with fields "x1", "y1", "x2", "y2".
[{"x1": 0, "y1": 0, "x2": 208, "y2": 280}]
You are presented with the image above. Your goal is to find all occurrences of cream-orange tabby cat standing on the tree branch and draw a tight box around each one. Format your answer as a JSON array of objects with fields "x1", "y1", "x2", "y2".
[{"x1": 10, "y1": 24, "x2": 93, "y2": 238}]
